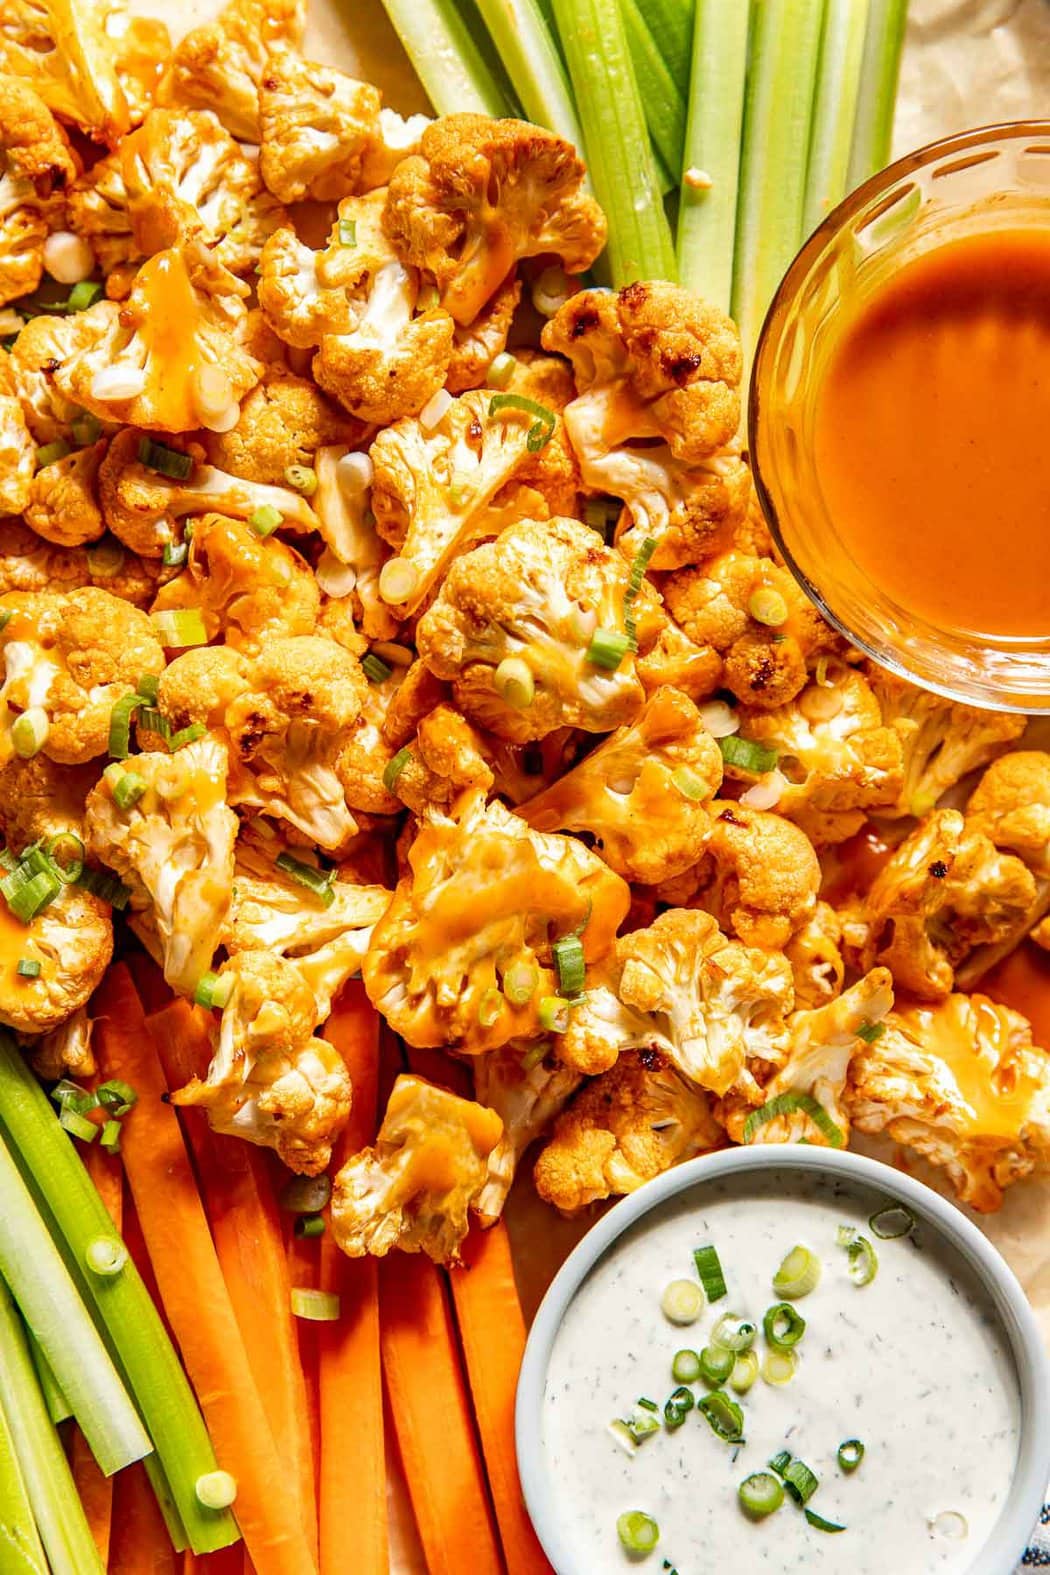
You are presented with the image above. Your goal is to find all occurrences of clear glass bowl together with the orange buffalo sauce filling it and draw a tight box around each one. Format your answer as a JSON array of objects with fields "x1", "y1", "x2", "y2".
[{"x1": 749, "y1": 121, "x2": 1050, "y2": 712}]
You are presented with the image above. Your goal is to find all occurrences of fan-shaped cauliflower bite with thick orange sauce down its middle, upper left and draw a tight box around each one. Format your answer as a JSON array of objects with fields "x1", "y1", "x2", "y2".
[{"x1": 54, "y1": 241, "x2": 263, "y2": 432}]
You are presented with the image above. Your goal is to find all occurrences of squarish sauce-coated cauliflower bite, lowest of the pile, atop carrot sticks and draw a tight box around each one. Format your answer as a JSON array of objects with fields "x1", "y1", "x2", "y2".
[{"x1": 331, "y1": 1076, "x2": 502, "y2": 1263}]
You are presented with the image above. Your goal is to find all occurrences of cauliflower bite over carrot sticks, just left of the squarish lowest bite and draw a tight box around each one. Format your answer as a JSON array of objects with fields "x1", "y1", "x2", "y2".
[{"x1": 172, "y1": 951, "x2": 351, "y2": 1175}]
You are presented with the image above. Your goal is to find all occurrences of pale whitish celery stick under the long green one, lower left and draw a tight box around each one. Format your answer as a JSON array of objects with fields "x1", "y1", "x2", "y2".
[{"x1": 0, "y1": 1142, "x2": 153, "y2": 1476}]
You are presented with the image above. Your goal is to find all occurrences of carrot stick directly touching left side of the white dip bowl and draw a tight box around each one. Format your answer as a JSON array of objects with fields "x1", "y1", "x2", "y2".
[{"x1": 449, "y1": 1221, "x2": 551, "y2": 1575}]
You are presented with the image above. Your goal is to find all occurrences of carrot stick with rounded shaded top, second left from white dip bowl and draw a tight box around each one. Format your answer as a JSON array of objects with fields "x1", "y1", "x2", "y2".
[{"x1": 379, "y1": 1252, "x2": 502, "y2": 1575}]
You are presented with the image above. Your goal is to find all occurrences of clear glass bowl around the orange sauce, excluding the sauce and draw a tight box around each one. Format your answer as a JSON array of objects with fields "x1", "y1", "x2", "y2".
[{"x1": 748, "y1": 120, "x2": 1050, "y2": 713}]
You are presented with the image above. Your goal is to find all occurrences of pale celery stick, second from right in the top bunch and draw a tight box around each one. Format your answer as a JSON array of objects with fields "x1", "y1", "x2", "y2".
[{"x1": 803, "y1": 0, "x2": 869, "y2": 235}]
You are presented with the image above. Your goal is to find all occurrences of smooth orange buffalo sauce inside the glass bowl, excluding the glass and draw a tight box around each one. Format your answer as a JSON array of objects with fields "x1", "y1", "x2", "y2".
[{"x1": 814, "y1": 227, "x2": 1050, "y2": 639}]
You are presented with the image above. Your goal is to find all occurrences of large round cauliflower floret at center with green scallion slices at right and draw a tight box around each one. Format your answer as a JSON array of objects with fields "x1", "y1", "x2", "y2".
[{"x1": 417, "y1": 513, "x2": 663, "y2": 743}]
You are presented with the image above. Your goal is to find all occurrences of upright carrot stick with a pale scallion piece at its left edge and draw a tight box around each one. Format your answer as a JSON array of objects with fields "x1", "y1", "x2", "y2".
[{"x1": 316, "y1": 981, "x2": 390, "y2": 1575}]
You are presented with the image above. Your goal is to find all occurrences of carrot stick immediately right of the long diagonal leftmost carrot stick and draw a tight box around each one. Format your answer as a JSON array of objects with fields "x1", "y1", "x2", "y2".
[{"x1": 146, "y1": 1000, "x2": 316, "y2": 1547}]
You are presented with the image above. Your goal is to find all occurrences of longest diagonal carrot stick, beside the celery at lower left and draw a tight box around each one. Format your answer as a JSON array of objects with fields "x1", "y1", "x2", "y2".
[{"x1": 96, "y1": 964, "x2": 316, "y2": 1575}]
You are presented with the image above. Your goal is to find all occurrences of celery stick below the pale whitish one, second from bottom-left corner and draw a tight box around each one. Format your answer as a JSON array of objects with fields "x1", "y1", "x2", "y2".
[{"x1": 0, "y1": 1280, "x2": 105, "y2": 1575}]
